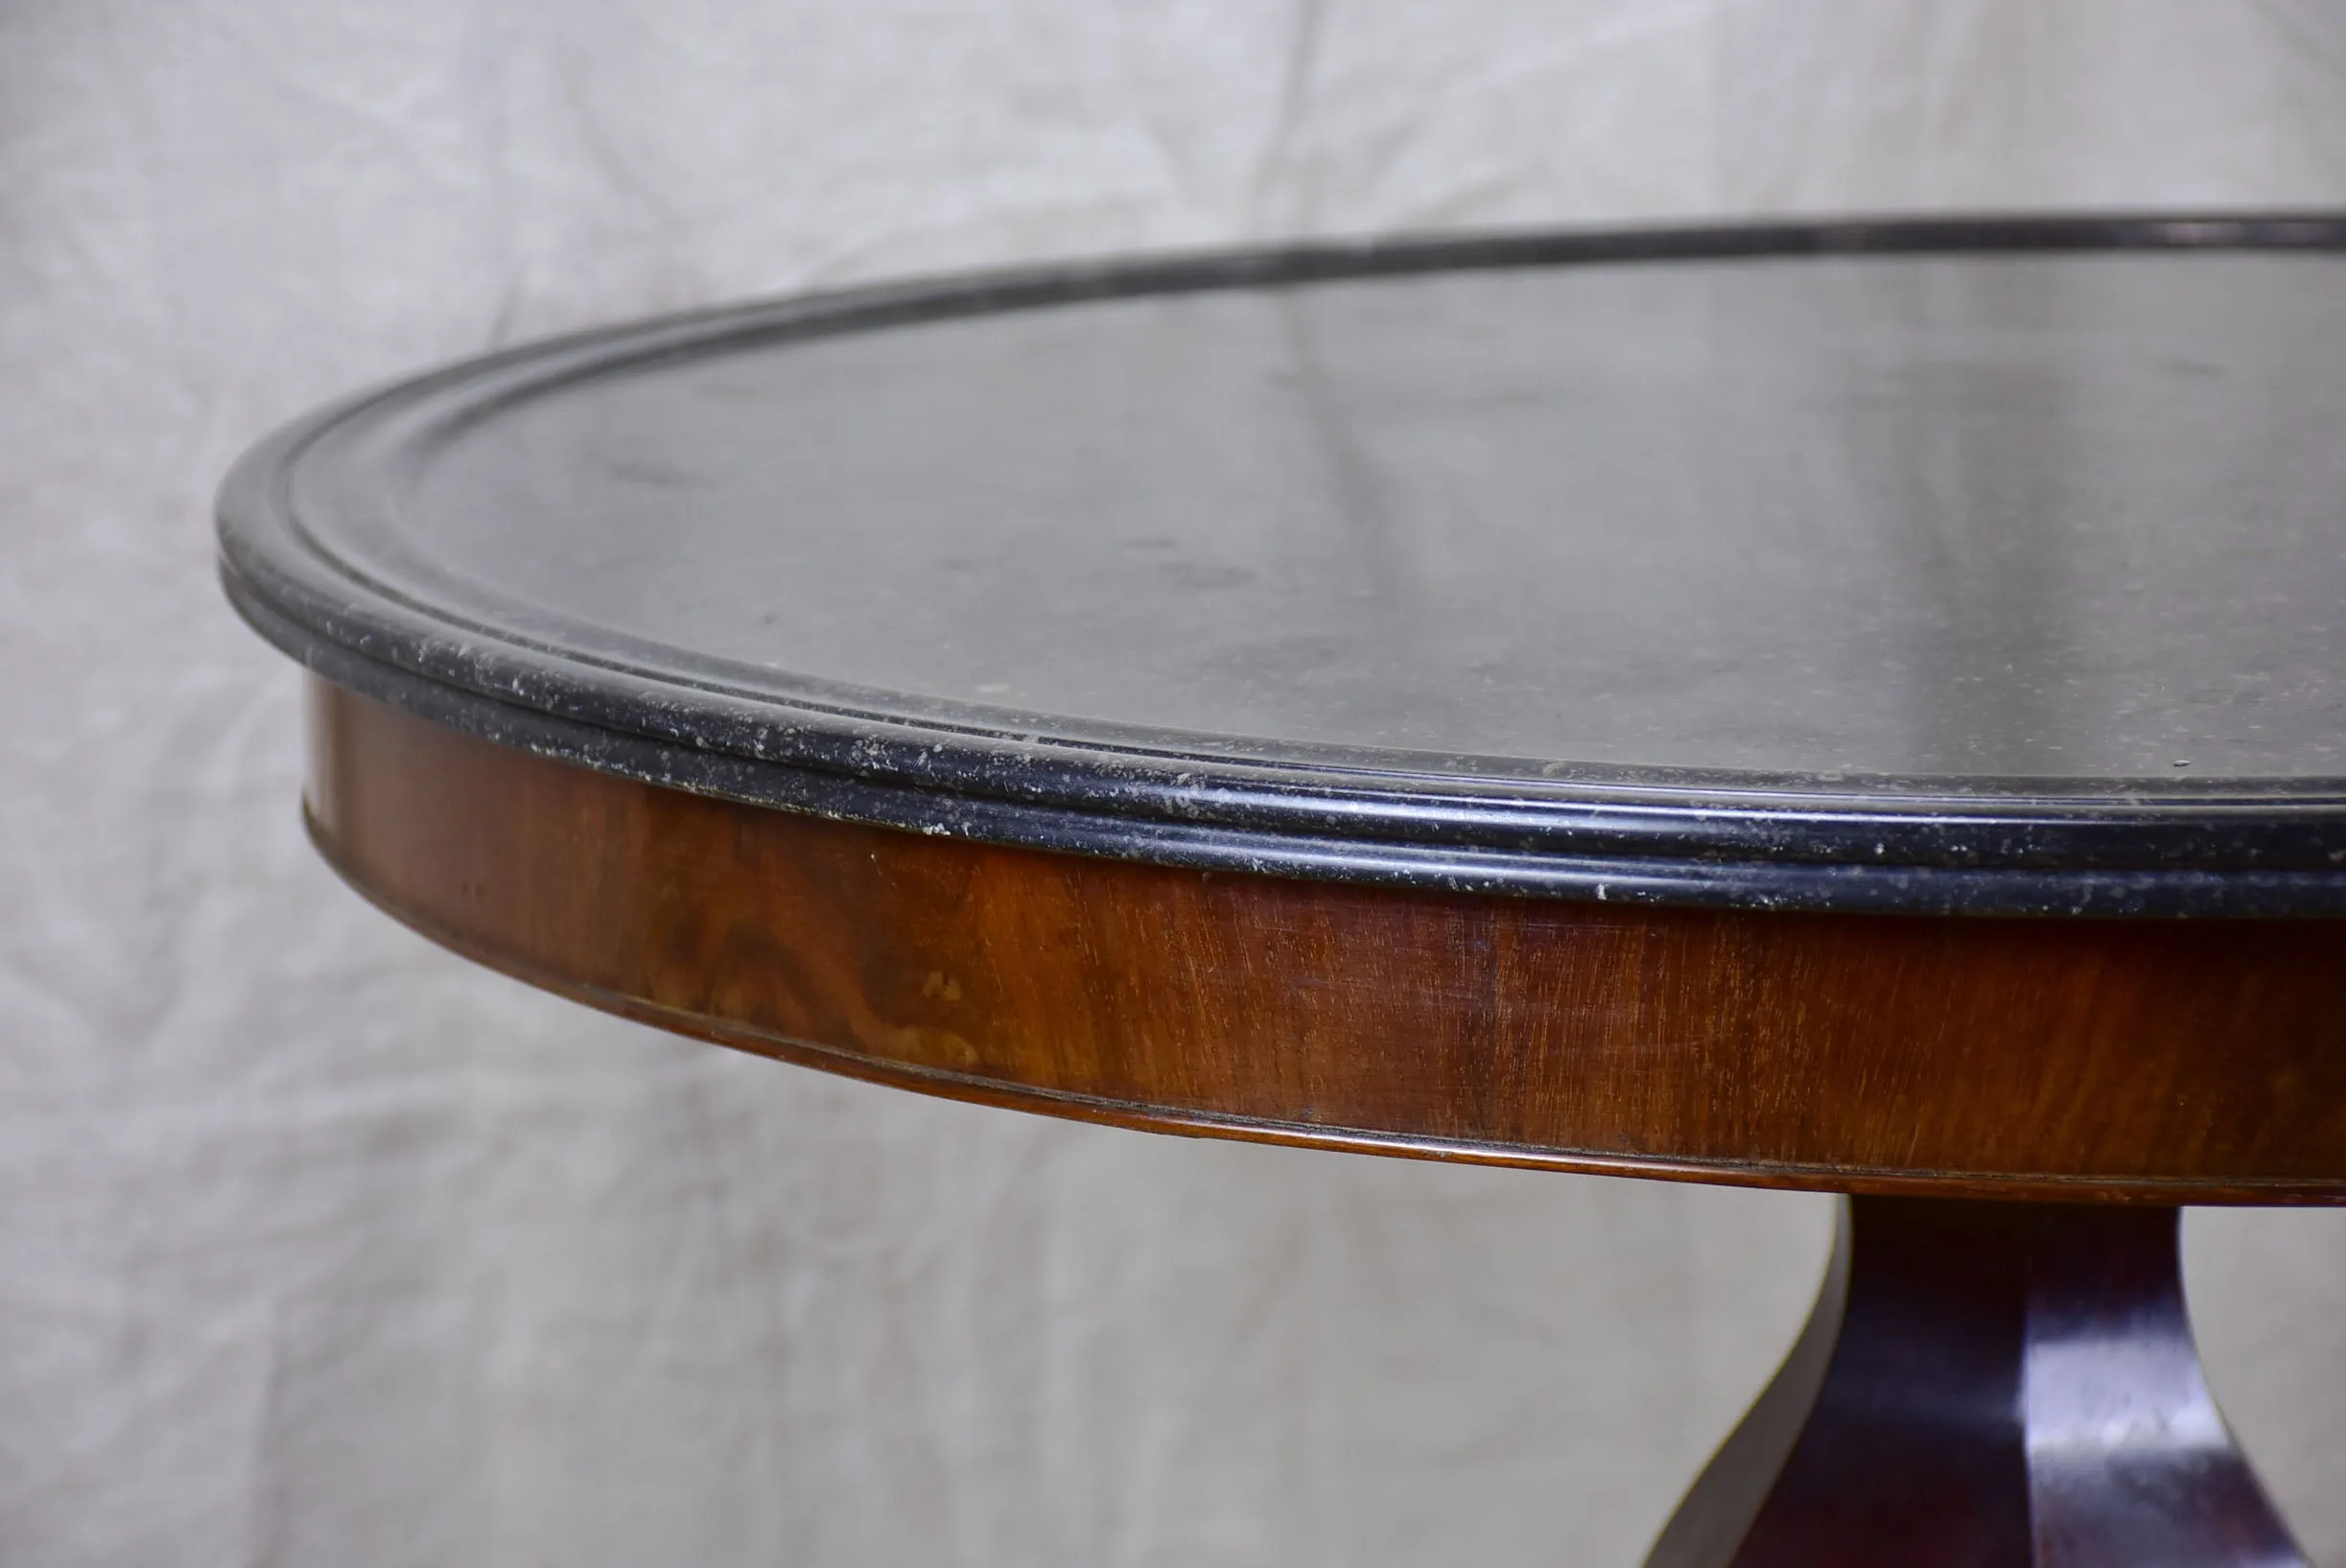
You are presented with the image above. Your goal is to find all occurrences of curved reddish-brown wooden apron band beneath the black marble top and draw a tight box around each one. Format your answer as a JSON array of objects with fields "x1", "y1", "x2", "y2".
[{"x1": 310, "y1": 681, "x2": 2346, "y2": 1205}]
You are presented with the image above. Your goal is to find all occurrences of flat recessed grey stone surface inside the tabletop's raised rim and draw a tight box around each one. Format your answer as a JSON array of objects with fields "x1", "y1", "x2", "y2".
[{"x1": 321, "y1": 256, "x2": 2346, "y2": 784}]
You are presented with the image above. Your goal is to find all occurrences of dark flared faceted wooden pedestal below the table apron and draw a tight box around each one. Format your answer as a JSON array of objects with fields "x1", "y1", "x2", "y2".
[{"x1": 1647, "y1": 1197, "x2": 2304, "y2": 1568}]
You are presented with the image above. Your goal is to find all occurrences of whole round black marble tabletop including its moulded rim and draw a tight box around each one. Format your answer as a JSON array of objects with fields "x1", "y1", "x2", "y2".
[{"x1": 223, "y1": 219, "x2": 2346, "y2": 916}]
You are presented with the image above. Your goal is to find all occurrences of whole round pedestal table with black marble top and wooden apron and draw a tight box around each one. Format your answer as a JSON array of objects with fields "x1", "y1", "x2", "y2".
[{"x1": 221, "y1": 216, "x2": 2346, "y2": 1568}]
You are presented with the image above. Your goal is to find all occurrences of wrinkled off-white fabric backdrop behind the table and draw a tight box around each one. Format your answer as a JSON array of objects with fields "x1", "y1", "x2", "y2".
[{"x1": 0, "y1": 0, "x2": 2346, "y2": 1568}]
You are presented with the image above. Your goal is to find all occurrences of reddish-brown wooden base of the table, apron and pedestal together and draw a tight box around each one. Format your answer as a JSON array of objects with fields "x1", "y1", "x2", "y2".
[{"x1": 310, "y1": 683, "x2": 2346, "y2": 1568}]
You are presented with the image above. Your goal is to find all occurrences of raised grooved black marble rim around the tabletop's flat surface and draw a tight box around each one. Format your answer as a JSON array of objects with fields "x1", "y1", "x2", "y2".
[{"x1": 221, "y1": 214, "x2": 2346, "y2": 916}]
